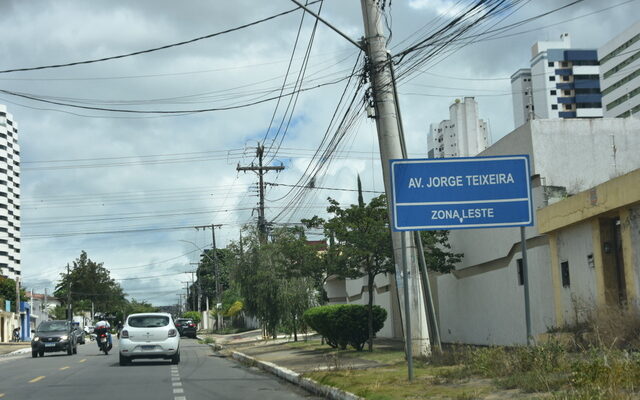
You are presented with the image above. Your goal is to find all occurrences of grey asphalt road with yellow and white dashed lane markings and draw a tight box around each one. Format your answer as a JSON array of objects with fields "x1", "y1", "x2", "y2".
[{"x1": 0, "y1": 338, "x2": 318, "y2": 400}]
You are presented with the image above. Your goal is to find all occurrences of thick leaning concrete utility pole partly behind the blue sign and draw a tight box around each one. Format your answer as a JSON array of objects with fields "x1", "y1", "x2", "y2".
[{"x1": 361, "y1": 0, "x2": 431, "y2": 357}]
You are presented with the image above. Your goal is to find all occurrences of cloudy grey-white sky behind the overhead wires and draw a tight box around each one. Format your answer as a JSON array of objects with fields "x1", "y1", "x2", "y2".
[{"x1": 0, "y1": 0, "x2": 640, "y2": 305}]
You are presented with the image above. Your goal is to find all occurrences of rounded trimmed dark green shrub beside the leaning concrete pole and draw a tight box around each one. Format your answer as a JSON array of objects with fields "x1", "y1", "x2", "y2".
[{"x1": 303, "y1": 304, "x2": 387, "y2": 351}]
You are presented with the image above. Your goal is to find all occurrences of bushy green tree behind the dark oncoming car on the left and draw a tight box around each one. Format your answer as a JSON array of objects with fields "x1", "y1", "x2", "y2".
[{"x1": 54, "y1": 251, "x2": 127, "y2": 314}]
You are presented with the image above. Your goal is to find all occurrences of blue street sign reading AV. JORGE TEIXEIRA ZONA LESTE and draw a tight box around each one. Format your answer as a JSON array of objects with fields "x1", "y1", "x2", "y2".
[{"x1": 390, "y1": 155, "x2": 533, "y2": 231}]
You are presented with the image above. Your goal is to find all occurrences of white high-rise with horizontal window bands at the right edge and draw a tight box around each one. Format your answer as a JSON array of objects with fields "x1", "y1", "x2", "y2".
[{"x1": 598, "y1": 22, "x2": 640, "y2": 118}]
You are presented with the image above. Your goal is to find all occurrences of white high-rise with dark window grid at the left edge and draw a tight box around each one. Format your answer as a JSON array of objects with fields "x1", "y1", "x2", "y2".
[{"x1": 0, "y1": 104, "x2": 21, "y2": 279}]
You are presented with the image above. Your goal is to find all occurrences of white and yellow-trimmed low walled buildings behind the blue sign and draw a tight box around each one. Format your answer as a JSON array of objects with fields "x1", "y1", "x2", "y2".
[{"x1": 434, "y1": 118, "x2": 640, "y2": 345}]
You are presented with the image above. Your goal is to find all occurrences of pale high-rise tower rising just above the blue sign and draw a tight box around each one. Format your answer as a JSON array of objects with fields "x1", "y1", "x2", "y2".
[{"x1": 427, "y1": 97, "x2": 489, "y2": 158}]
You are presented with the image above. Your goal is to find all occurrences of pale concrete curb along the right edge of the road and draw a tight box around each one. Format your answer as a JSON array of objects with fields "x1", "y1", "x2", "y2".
[{"x1": 231, "y1": 351, "x2": 364, "y2": 400}]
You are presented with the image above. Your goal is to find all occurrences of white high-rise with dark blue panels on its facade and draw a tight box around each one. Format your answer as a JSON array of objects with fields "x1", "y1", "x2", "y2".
[{"x1": 511, "y1": 33, "x2": 603, "y2": 127}]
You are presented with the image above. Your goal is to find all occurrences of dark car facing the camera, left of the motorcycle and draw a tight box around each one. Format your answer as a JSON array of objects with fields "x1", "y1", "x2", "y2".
[{"x1": 31, "y1": 321, "x2": 78, "y2": 358}]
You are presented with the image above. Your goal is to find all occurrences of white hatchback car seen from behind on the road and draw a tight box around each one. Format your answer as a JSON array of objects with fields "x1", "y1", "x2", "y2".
[{"x1": 119, "y1": 313, "x2": 180, "y2": 365}]
